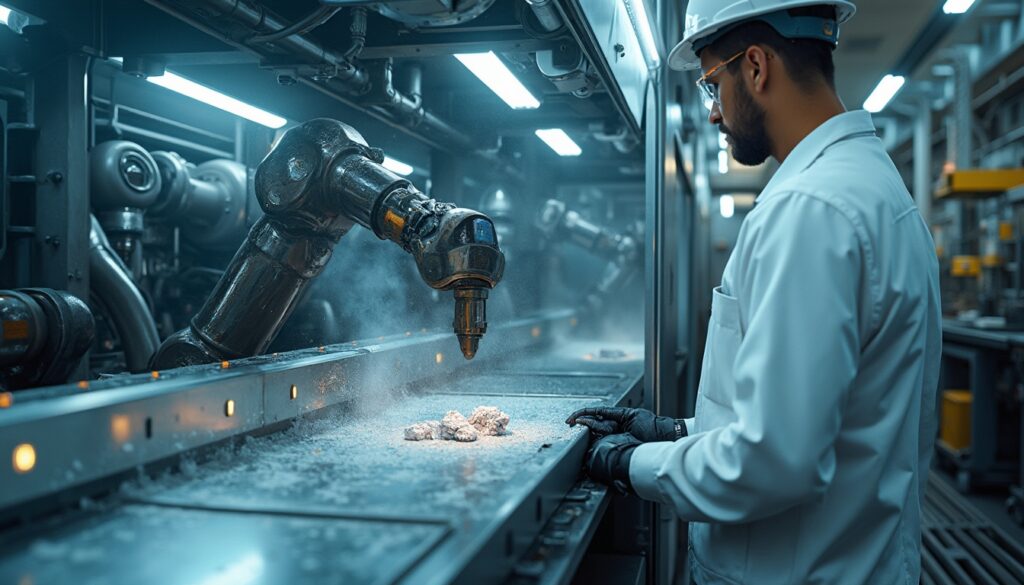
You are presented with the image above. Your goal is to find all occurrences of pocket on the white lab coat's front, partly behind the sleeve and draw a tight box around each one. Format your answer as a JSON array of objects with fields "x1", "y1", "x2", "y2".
[{"x1": 694, "y1": 287, "x2": 743, "y2": 432}]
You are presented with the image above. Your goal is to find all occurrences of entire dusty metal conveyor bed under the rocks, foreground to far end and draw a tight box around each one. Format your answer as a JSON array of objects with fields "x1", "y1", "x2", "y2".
[{"x1": 0, "y1": 349, "x2": 642, "y2": 584}]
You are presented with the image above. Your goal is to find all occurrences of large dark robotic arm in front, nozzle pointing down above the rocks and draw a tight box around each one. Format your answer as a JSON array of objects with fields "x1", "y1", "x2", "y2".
[{"x1": 154, "y1": 119, "x2": 505, "y2": 369}]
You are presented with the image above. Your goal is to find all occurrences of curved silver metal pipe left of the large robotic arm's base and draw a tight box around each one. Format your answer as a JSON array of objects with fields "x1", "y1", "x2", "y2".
[{"x1": 89, "y1": 216, "x2": 160, "y2": 372}]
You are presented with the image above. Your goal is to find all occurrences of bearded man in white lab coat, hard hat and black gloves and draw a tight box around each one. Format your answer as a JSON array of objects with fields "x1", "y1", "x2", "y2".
[{"x1": 568, "y1": 0, "x2": 941, "y2": 584}]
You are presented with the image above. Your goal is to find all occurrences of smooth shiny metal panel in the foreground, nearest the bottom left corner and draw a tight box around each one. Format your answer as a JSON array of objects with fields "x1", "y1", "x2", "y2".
[{"x1": 0, "y1": 505, "x2": 451, "y2": 585}]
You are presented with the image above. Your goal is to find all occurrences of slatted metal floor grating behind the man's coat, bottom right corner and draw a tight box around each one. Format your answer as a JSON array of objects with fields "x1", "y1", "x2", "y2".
[{"x1": 921, "y1": 476, "x2": 1024, "y2": 585}]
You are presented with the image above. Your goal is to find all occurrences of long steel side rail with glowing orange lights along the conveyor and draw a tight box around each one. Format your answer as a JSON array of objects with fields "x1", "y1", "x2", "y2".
[{"x1": 0, "y1": 311, "x2": 572, "y2": 516}]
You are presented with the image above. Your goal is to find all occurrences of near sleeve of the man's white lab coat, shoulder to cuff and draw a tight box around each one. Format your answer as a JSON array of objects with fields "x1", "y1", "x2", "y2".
[{"x1": 630, "y1": 194, "x2": 869, "y2": 523}]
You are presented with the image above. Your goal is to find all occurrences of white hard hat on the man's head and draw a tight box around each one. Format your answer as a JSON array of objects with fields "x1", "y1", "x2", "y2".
[{"x1": 669, "y1": 0, "x2": 857, "y2": 71}]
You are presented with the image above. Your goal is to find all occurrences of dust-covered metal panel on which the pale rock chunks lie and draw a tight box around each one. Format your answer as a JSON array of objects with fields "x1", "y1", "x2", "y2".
[{"x1": 131, "y1": 394, "x2": 595, "y2": 518}]
